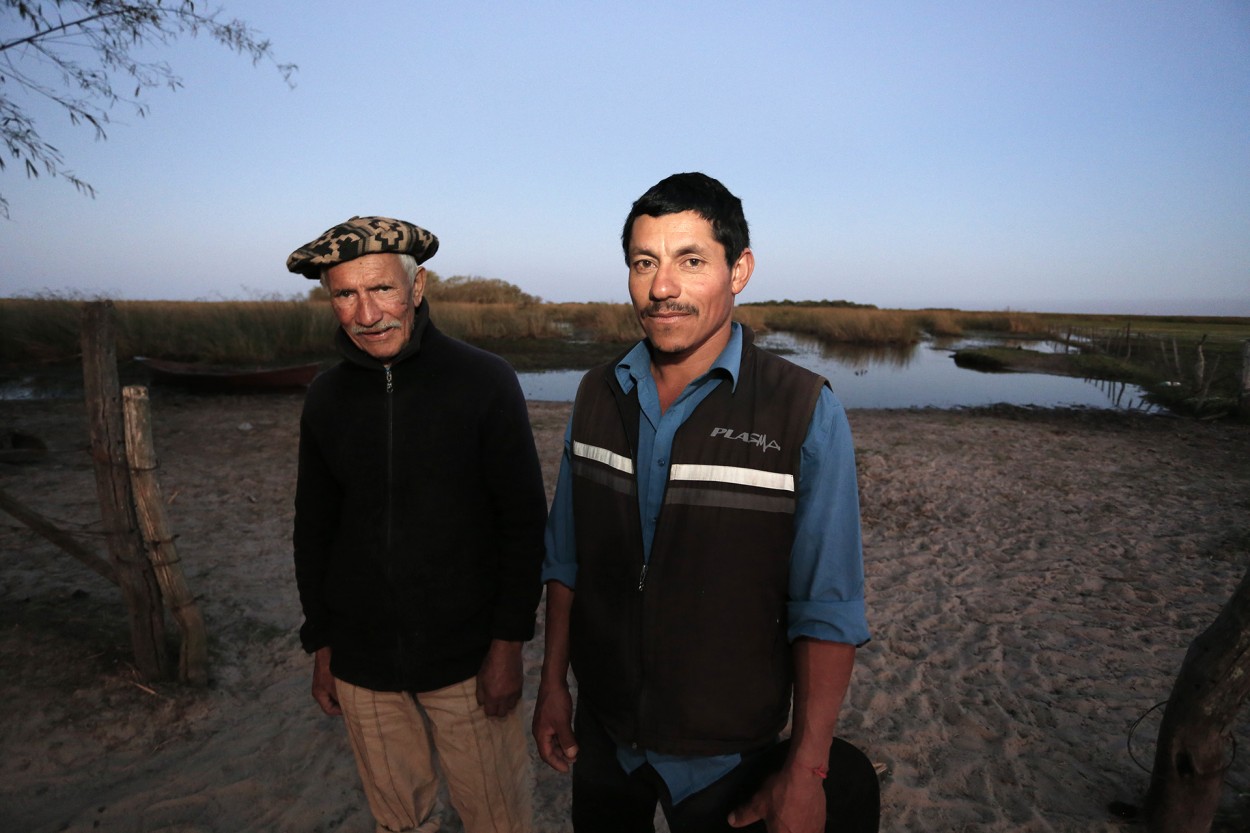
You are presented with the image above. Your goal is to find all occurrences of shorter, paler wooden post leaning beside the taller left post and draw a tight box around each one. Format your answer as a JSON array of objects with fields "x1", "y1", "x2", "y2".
[{"x1": 121, "y1": 385, "x2": 209, "y2": 687}]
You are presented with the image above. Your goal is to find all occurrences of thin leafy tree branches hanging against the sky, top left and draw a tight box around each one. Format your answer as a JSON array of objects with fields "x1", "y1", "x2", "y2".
[{"x1": 0, "y1": 0, "x2": 296, "y2": 218}]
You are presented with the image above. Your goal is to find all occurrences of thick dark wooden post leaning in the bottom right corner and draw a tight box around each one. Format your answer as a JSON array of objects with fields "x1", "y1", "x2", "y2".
[{"x1": 1146, "y1": 560, "x2": 1250, "y2": 833}]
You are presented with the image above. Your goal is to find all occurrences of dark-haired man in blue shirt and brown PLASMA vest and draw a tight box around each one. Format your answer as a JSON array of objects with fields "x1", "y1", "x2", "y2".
[{"x1": 534, "y1": 174, "x2": 879, "y2": 833}]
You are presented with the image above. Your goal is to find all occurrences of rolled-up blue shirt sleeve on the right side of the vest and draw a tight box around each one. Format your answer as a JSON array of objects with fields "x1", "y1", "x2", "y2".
[{"x1": 790, "y1": 386, "x2": 870, "y2": 645}]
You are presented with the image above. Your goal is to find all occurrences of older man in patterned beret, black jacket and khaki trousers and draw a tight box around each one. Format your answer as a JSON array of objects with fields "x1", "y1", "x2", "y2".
[{"x1": 286, "y1": 216, "x2": 546, "y2": 833}]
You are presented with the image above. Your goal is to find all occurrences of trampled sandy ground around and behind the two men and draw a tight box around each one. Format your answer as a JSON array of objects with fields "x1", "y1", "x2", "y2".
[{"x1": 0, "y1": 391, "x2": 1250, "y2": 833}]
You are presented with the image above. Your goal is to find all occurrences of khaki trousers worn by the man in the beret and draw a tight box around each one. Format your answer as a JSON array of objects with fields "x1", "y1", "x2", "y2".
[{"x1": 335, "y1": 677, "x2": 533, "y2": 833}]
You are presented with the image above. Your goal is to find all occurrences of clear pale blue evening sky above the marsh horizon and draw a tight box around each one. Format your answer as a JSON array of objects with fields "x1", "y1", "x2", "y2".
[{"x1": 0, "y1": 0, "x2": 1250, "y2": 315}]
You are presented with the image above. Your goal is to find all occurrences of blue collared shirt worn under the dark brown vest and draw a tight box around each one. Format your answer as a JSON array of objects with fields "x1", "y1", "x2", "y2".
[{"x1": 543, "y1": 324, "x2": 869, "y2": 803}]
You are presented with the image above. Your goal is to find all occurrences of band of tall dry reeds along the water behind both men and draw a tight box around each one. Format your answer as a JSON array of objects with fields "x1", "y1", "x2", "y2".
[{"x1": 0, "y1": 296, "x2": 1065, "y2": 364}]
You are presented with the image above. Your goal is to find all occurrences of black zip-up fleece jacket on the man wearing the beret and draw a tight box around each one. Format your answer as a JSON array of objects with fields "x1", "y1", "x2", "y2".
[{"x1": 294, "y1": 301, "x2": 546, "y2": 692}]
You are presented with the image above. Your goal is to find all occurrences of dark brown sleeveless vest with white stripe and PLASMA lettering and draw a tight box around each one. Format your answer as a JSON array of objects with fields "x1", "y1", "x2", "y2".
[{"x1": 571, "y1": 330, "x2": 825, "y2": 754}]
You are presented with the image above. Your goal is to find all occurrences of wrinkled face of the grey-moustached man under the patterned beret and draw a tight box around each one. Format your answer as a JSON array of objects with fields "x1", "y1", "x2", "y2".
[{"x1": 325, "y1": 254, "x2": 425, "y2": 361}]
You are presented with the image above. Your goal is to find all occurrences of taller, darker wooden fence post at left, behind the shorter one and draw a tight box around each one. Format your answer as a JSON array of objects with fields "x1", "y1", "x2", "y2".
[{"x1": 83, "y1": 301, "x2": 169, "y2": 680}]
